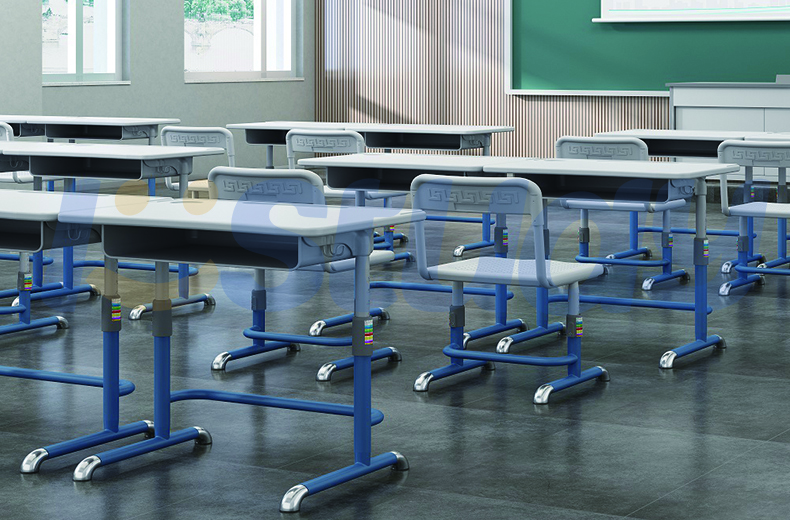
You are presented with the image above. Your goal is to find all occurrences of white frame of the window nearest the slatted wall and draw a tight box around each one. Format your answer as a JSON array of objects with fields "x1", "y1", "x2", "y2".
[{"x1": 184, "y1": 0, "x2": 304, "y2": 83}]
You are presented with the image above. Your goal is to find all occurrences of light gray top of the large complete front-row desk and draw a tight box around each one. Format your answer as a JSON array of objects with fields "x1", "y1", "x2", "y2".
[{"x1": 58, "y1": 199, "x2": 425, "y2": 237}]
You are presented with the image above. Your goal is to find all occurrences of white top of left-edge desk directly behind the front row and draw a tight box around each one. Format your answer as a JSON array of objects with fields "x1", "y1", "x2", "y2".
[{"x1": 0, "y1": 141, "x2": 225, "y2": 161}]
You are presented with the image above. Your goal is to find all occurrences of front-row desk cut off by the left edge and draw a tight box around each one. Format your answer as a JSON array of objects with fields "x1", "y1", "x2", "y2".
[{"x1": 0, "y1": 190, "x2": 167, "y2": 473}]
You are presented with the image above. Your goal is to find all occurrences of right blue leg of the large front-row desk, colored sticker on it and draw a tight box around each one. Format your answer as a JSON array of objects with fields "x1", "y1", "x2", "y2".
[{"x1": 280, "y1": 257, "x2": 409, "y2": 513}]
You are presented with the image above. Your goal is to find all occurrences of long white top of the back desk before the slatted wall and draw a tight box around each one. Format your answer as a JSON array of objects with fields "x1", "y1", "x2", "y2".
[{"x1": 228, "y1": 121, "x2": 515, "y2": 135}]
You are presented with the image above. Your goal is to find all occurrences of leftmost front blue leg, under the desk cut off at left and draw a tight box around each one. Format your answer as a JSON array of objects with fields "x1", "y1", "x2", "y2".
[{"x1": 20, "y1": 259, "x2": 148, "y2": 473}]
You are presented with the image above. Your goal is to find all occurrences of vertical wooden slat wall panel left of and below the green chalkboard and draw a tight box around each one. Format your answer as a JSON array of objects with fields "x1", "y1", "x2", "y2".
[{"x1": 316, "y1": 0, "x2": 669, "y2": 157}]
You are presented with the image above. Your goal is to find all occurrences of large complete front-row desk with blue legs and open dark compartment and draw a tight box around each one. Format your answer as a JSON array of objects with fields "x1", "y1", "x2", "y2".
[{"x1": 59, "y1": 199, "x2": 425, "y2": 512}]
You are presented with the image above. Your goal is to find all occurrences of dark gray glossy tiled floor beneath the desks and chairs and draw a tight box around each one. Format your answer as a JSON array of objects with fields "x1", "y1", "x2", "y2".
[{"x1": 0, "y1": 196, "x2": 790, "y2": 520}]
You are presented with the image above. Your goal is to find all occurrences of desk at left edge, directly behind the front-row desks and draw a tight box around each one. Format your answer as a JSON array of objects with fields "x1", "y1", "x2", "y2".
[{"x1": 0, "y1": 141, "x2": 225, "y2": 312}]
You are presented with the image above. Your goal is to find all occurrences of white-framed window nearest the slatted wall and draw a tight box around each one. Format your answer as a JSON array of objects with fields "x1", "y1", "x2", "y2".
[{"x1": 184, "y1": 0, "x2": 302, "y2": 82}]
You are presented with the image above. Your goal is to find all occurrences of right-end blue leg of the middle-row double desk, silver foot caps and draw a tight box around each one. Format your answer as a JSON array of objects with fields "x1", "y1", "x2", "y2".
[{"x1": 659, "y1": 178, "x2": 727, "y2": 369}]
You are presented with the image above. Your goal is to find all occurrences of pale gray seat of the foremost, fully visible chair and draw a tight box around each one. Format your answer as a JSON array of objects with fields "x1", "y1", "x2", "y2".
[{"x1": 428, "y1": 257, "x2": 604, "y2": 287}]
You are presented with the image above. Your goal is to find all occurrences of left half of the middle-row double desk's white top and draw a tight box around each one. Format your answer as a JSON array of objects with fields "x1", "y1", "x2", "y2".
[{"x1": 299, "y1": 153, "x2": 510, "y2": 173}]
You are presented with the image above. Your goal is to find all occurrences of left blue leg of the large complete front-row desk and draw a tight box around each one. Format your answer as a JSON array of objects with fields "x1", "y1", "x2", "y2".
[{"x1": 73, "y1": 262, "x2": 211, "y2": 482}]
